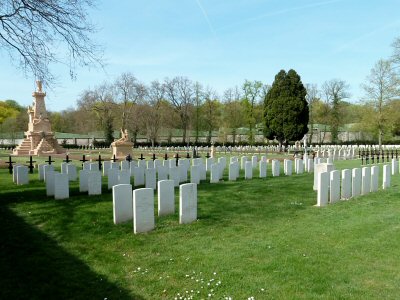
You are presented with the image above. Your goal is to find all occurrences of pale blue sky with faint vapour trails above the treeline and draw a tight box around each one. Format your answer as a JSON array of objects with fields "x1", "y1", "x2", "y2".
[{"x1": 0, "y1": 0, "x2": 400, "y2": 111}]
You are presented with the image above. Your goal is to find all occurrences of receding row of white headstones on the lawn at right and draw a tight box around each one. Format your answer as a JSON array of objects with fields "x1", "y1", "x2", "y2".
[{"x1": 314, "y1": 159, "x2": 399, "y2": 206}]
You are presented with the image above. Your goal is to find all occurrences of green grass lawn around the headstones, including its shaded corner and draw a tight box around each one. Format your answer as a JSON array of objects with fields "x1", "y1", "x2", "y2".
[{"x1": 0, "y1": 155, "x2": 400, "y2": 299}]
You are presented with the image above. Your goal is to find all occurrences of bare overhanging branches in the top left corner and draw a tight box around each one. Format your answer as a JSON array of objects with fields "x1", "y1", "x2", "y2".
[{"x1": 0, "y1": 0, "x2": 101, "y2": 84}]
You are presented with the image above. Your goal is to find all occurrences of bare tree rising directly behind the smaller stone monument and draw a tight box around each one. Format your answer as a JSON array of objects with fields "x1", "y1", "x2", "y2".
[{"x1": 114, "y1": 73, "x2": 146, "y2": 130}]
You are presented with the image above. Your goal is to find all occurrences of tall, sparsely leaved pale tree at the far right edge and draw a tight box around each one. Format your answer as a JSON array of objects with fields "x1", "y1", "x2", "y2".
[{"x1": 362, "y1": 59, "x2": 400, "y2": 148}]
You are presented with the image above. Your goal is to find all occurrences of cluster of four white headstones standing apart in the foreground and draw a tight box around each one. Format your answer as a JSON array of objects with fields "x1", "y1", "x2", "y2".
[{"x1": 112, "y1": 180, "x2": 197, "y2": 234}]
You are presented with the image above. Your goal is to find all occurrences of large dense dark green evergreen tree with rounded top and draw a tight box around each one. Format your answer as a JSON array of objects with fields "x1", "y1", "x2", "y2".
[{"x1": 264, "y1": 70, "x2": 309, "y2": 145}]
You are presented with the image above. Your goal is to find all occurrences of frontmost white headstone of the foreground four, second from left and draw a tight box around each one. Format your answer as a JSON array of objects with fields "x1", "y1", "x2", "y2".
[{"x1": 133, "y1": 188, "x2": 155, "y2": 234}]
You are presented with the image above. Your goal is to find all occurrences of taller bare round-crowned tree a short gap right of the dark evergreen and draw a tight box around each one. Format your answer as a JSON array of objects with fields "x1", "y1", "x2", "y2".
[{"x1": 322, "y1": 79, "x2": 350, "y2": 143}]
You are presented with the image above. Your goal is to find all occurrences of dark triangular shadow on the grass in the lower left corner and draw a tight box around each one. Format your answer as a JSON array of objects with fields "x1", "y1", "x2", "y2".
[{"x1": 0, "y1": 205, "x2": 143, "y2": 299}]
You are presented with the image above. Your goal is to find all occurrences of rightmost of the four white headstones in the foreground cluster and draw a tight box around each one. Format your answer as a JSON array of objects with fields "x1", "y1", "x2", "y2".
[{"x1": 179, "y1": 183, "x2": 197, "y2": 224}]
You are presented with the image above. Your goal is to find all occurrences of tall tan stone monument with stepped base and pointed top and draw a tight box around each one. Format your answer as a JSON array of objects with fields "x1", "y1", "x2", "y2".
[{"x1": 14, "y1": 81, "x2": 65, "y2": 155}]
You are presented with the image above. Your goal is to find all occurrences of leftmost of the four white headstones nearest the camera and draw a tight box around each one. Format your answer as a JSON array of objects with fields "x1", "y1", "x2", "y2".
[{"x1": 112, "y1": 184, "x2": 133, "y2": 224}]
